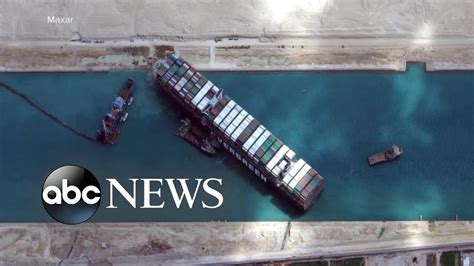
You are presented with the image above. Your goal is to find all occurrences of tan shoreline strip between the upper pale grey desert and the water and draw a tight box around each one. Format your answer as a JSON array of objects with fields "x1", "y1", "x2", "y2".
[{"x1": 0, "y1": 38, "x2": 474, "y2": 73}]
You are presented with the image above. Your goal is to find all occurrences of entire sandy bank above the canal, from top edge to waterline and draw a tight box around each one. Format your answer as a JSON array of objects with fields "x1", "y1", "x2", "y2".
[{"x1": 0, "y1": 0, "x2": 474, "y2": 71}]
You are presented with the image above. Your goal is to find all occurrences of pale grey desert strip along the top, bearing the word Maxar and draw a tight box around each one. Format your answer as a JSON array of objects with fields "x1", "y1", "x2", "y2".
[{"x1": 0, "y1": 0, "x2": 474, "y2": 40}]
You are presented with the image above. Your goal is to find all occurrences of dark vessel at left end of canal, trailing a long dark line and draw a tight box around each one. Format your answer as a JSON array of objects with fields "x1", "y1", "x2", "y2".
[{"x1": 97, "y1": 77, "x2": 135, "y2": 144}]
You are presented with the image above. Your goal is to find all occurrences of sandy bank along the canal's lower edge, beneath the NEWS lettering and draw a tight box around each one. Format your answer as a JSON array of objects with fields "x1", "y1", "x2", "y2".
[{"x1": 0, "y1": 221, "x2": 474, "y2": 264}]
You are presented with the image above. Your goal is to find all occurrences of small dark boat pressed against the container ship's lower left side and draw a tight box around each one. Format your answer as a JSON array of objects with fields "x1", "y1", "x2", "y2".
[{"x1": 176, "y1": 118, "x2": 220, "y2": 155}]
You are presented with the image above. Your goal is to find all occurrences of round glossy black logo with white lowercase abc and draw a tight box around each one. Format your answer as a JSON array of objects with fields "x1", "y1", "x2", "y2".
[{"x1": 41, "y1": 165, "x2": 100, "y2": 224}]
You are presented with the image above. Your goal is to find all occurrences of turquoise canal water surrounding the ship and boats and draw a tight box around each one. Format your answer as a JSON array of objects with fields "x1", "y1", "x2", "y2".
[{"x1": 0, "y1": 65, "x2": 474, "y2": 222}]
